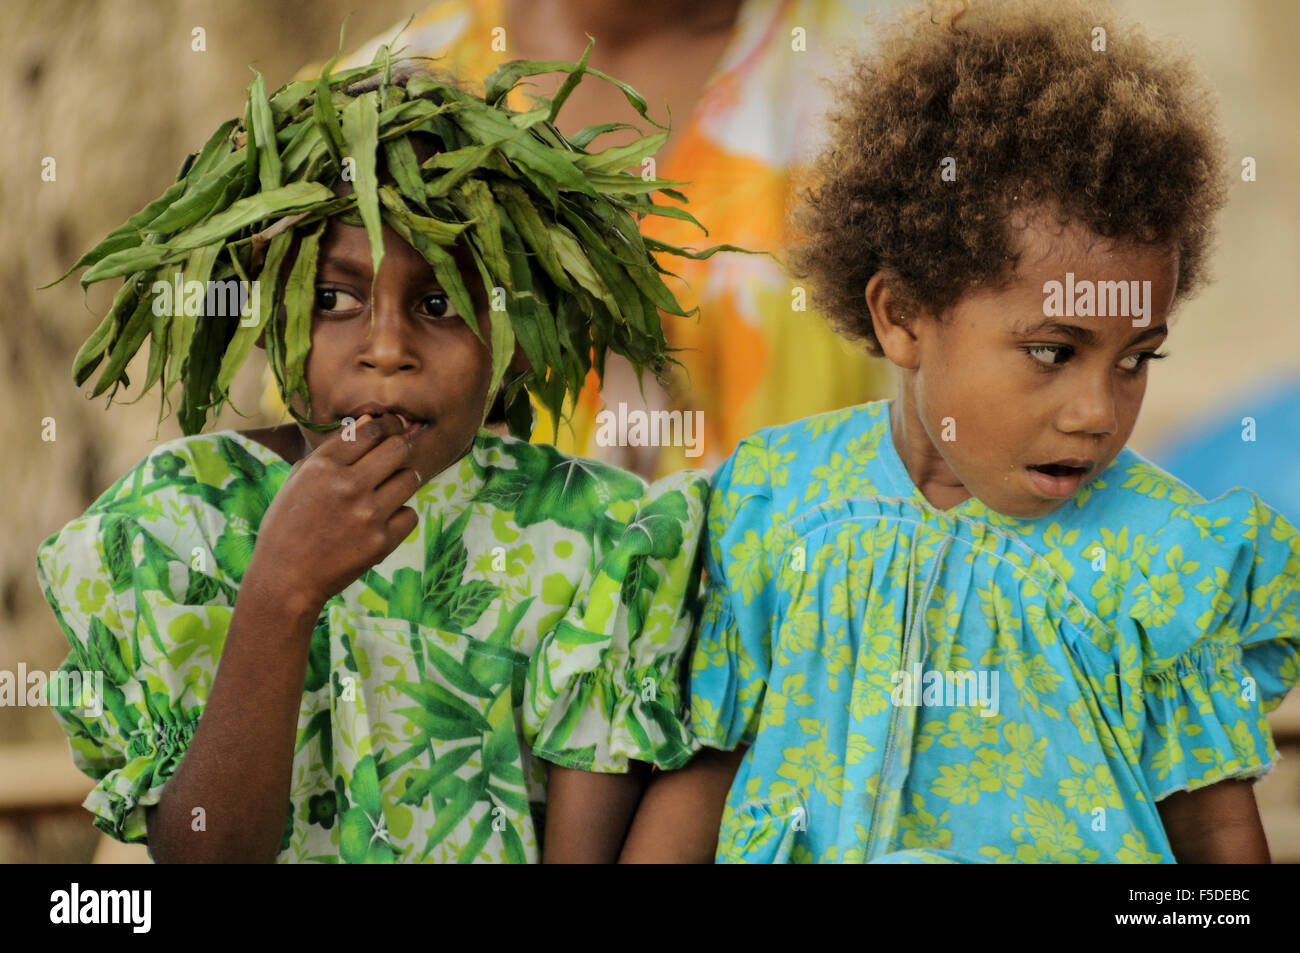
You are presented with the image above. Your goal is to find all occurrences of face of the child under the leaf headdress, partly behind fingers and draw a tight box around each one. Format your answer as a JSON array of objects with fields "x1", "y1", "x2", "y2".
[{"x1": 295, "y1": 220, "x2": 491, "y2": 480}]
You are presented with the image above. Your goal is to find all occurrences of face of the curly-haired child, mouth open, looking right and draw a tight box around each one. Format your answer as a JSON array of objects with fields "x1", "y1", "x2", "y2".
[{"x1": 883, "y1": 214, "x2": 1178, "y2": 519}]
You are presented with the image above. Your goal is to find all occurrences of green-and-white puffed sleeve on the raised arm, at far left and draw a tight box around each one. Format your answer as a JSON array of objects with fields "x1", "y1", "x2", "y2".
[{"x1": 36, "y1": 507, "x2": 233, "y2": 842}]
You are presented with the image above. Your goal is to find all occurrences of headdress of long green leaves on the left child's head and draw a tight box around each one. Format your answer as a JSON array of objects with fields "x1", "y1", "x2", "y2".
[{"x1": 48, "y1": 39, "x2": 745, "y2": 436}]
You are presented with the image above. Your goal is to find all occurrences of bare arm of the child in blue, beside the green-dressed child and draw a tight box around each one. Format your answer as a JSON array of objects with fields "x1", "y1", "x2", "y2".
[{"x1": 619, "y1": 748, "x2": 745, "y2": 863}]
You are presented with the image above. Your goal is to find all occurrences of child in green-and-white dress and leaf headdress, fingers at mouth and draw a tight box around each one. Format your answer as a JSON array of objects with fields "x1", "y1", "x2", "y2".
[{"x1": 38, "y1": 49, "x2": 709, "y2": 863}]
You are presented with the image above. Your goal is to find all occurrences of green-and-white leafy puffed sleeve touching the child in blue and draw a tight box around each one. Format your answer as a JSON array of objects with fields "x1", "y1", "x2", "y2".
[{"x1": 524, "y1": 472, "x2": 709, "y2": 774}]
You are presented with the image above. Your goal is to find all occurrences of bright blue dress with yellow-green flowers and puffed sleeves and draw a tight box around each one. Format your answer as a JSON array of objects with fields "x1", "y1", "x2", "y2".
[{"x1": 690, "y1": 402, "x2": 1300, "y2": 863}]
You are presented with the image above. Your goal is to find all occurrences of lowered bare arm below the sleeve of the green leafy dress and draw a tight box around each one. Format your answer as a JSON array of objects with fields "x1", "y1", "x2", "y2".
[{"x1": 542, "y1": 761, "x2": 647, "y2": 863}]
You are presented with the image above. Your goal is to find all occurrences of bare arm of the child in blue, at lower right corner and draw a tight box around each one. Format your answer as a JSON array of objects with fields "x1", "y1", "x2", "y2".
[{"x1": 1157, "y1": 780, "x2": 1270, "y2": 863}]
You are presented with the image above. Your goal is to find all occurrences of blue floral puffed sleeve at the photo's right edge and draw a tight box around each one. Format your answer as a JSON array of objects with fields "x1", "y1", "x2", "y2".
[{"x1": 1119, "y1": 489, "x2": 1300, "y2": 800}]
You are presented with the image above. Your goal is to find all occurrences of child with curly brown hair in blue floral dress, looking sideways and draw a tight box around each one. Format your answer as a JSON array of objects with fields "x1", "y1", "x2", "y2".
[{"x1": 625, "y1": 4, "x2": 1300, "y2": 863}]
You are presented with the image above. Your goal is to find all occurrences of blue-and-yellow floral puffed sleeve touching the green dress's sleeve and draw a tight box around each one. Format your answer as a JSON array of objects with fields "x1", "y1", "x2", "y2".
[{"x1": 690, "y1": 434, "x2": 775, "y2": 751}]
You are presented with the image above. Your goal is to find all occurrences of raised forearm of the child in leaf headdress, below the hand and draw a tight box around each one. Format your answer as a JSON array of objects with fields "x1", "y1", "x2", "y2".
[{"x1": 146, "y1": 577, "x2": 319, "y2": 863}]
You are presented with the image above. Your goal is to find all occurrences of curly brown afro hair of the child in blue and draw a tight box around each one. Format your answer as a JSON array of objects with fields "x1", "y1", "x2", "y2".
[{"x1": 789, "y1": 0, "x2": 1226, "y2": 355}]
